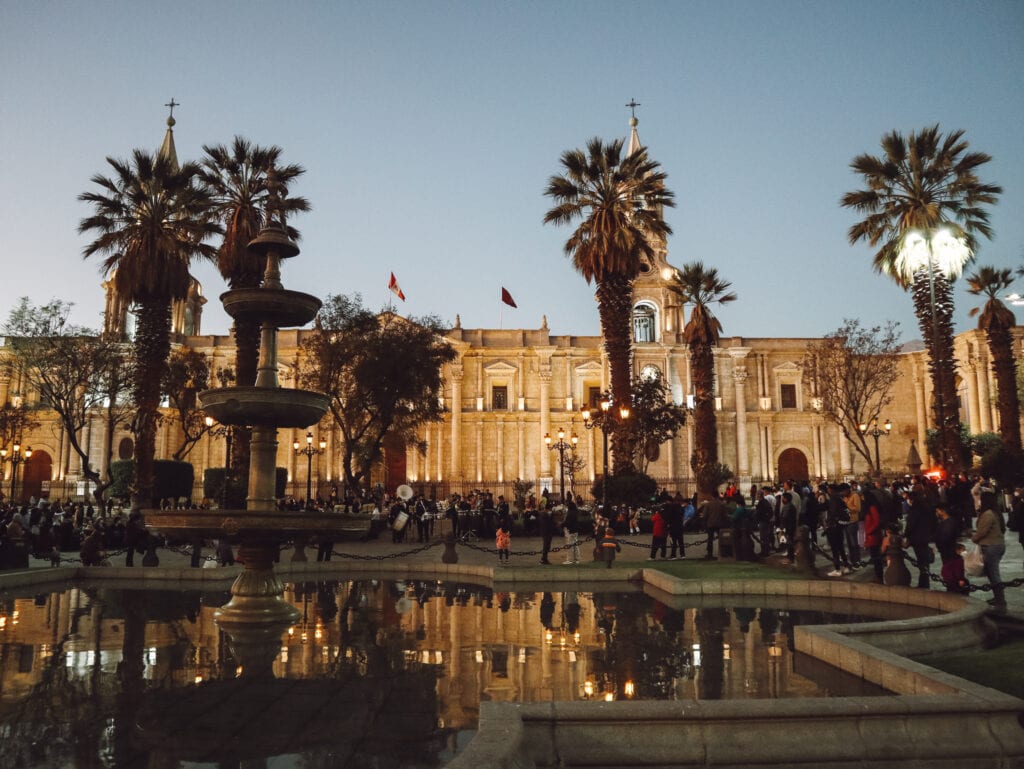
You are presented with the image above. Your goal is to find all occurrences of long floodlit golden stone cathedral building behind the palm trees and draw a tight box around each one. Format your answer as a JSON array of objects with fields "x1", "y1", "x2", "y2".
[{"x1": 0, "y1": 112, "x2": 1024, "y2": 498}]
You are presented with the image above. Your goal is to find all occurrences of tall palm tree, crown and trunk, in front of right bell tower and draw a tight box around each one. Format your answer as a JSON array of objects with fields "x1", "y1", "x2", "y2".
[{"x1": 544, "y1": 137, "x2": 675, "y2": 474}]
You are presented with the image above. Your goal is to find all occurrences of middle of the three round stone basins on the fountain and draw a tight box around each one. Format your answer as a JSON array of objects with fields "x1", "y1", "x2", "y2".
[{"x1": 199, "y1": 387, "x2": 331, "y2": 427}]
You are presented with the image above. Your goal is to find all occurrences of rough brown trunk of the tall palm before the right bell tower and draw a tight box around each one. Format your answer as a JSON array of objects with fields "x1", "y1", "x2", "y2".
[{"x1": 596, "y1": 274, "x2": 634, "y2": 475}]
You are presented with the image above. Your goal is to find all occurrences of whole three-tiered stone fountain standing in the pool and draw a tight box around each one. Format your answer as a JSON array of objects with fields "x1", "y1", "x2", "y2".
[{"x1": 146, "y1": 190, "x2": 352, "y2": 675}]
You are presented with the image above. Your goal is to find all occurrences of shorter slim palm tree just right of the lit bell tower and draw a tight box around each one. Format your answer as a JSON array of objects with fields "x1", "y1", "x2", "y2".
[{"x1": 668, "y1": 262, "x2": 736, "y2": 499}]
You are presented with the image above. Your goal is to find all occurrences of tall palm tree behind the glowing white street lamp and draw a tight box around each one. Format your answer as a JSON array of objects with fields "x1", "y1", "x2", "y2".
[{"x1": 842, "y1": 125, "x2": 1002, "y2": 471}]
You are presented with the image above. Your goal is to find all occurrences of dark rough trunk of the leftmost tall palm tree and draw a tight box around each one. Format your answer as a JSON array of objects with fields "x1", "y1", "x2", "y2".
[{"x1": 132, "y1": 301, "x2": 171, "y2": 509}]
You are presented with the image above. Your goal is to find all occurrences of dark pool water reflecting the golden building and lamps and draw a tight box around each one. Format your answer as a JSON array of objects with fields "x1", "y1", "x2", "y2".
[{"x1": 0, "y1": 581, "x2": 905, "y2": 769}]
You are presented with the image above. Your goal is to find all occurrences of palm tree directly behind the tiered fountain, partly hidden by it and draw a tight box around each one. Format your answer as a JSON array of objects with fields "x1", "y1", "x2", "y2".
[{"x1": 200, "y1": 136, "x2": 309, "y2": 509}]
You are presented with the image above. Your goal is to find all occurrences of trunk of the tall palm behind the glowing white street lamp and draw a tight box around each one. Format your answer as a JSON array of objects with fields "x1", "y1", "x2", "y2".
[{"x1": 911, "y1": 267, "x2": 964, "y2": 473}]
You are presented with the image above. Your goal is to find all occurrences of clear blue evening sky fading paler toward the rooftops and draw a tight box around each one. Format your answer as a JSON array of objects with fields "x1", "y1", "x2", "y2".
[{"x1": 0, "y1": 0, "x2": 1024, "y2": 341}]
